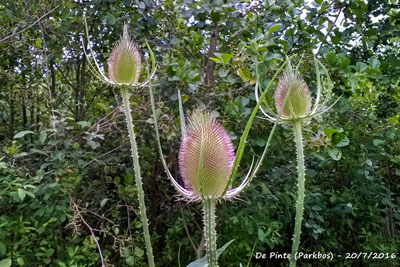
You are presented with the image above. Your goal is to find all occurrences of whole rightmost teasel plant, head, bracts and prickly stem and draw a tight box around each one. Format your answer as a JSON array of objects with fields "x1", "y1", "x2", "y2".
[{"x1": 255, "y1": 57, "x2": 340, "y2": 267}]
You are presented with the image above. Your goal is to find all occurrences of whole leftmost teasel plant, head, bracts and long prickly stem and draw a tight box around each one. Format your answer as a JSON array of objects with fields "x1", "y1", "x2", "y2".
[{"x1": 82, "y1": 18, "x2": 156, "y2": 267}]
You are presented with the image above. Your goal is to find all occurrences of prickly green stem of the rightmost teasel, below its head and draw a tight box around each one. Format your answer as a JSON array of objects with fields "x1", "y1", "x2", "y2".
[{"x1": 290, "y1": 120, "x2": 305, "y2": 267}]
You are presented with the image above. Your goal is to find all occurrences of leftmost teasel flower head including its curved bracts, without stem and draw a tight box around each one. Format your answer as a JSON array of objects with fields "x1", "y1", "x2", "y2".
[{"x1": 82, "y1": 18, "x2": 156, "y2": 87}]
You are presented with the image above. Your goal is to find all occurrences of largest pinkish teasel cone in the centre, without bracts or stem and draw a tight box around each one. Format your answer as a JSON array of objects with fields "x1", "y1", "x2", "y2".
[{"x1": 179, "y1": 112, "x2": 235, "y2": 199}]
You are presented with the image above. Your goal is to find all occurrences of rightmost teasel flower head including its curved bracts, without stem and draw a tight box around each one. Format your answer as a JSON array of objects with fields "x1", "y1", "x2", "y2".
[{"x1": 255, "y1": 58, "x2": 340, "y2": 123}]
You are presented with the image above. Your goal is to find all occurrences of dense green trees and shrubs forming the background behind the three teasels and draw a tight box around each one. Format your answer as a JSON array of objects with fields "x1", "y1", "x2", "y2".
[{"x1": 0, "y1": 0, "x2": 400, "y2": 267}]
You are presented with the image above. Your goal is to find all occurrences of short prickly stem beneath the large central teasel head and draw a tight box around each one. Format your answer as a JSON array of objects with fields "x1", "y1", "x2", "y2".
[{"x1": 203, "y1": 199, "x2": 218, "y2": 267}]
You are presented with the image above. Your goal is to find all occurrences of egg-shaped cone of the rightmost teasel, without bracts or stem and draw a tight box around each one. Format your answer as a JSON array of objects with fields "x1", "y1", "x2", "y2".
[{"x1": 275, "y1": 67, "x2": 312, "y2": 120}]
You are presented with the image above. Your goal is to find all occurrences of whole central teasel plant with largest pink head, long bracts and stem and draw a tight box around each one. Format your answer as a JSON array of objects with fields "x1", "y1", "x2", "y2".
[{"x1": 149, "y1": 61, "x2": 287, "y2": 267}]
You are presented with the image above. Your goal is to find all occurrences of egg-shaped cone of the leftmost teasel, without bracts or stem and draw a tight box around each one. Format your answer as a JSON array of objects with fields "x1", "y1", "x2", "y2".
[{"x1": 108, "y1": 25, "x2": 141, "y2": 85}]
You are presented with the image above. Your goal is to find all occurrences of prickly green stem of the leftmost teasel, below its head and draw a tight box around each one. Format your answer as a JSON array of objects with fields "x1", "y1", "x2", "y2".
[{"x1": 121, "y1": 87, "x2": 154, "y2": 267}]
